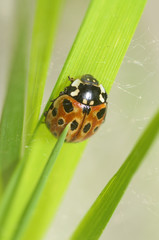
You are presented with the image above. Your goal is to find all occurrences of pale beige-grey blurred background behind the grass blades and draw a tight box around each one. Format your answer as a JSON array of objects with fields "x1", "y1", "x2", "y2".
[{"x1": 0, "y1": 0, "x2": 159, "y2": 240}]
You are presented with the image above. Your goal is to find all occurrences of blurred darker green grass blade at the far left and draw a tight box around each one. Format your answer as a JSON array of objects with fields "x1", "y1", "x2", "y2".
[{"x1": 0, "y1": 1, "x2": 29, "y2": 186}]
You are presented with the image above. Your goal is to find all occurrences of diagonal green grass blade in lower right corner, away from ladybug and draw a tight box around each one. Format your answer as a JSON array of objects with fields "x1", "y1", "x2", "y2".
[{"x1": 71, "y1": 111, "x2": 159, "y2": 240}]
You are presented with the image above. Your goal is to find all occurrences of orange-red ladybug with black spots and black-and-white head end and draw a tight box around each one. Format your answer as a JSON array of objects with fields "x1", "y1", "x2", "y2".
[{"x1": 45, "y1": 74, "x2": 107, "y2": 142}]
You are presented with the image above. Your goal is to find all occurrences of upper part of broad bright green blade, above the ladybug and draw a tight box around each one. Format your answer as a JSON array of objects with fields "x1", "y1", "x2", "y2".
[{"x1": 41, "y1": 0, "x2": 146, "y2": 101}]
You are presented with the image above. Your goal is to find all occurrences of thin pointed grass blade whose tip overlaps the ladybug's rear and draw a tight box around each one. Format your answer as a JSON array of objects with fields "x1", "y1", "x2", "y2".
[{"x1": 11, "y1": 126, "x2": 69, "y2": 240}]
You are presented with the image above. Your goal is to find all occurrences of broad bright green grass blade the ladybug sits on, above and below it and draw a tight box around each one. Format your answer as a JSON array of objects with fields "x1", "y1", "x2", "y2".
[{"x1": 25, "y1": 0, "x2": 146, "y2": 240}]
